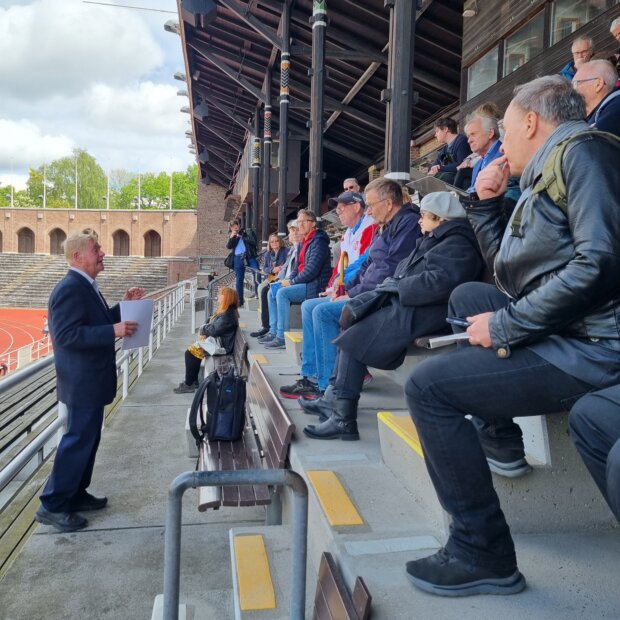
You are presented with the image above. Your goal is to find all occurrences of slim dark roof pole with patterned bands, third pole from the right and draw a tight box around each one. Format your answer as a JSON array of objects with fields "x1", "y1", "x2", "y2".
[{"x1": 278, "y1": 0, "x2": 291, "y2": 236}]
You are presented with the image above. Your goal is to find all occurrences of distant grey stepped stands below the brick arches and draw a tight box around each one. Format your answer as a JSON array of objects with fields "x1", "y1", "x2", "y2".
[{"x1": 0, "y1": 253, "x2": 168, "y2": 308}]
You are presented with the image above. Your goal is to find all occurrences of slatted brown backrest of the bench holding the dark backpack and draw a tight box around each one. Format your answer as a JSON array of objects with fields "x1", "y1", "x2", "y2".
[{"x1": 247, "y1": 362, "x2": 295, "y2": 469}]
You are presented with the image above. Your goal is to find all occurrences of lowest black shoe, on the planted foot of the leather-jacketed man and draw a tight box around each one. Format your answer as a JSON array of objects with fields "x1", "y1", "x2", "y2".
[{"x1": 407, "y1": 548, "x2": 525, "y2": 596}]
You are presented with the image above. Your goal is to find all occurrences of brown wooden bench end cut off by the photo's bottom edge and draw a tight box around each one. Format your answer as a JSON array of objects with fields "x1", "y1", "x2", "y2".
[{"x1": 312, "y1": 552, "x2": 372, "y2": 620}]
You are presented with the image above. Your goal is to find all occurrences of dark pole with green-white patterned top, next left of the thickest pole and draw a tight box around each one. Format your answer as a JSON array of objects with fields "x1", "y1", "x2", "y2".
[{"x1": 307, "y1": 0, "x2": 326, "y2": 215}]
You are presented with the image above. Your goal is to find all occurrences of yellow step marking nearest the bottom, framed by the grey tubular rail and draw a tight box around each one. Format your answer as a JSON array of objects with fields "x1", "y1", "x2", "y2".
[{"x1": 235, "y1": 534, "x2": 276, "y2": 611}]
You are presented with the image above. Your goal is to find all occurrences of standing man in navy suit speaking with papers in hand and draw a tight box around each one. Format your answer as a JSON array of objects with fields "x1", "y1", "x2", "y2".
[{"x1": 35, "y1": 229, "x2": 145, "y2": 532}]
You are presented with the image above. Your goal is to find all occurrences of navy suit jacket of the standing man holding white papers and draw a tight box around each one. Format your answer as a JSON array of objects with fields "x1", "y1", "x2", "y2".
[{"x1": 48, "y1": 270, "x2": 121, "y2": 407}]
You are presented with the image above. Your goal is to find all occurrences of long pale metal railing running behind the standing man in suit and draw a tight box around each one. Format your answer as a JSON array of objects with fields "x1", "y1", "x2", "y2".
[{"x1": 0, "y1": 278, "x2": 196, "y2": 491}]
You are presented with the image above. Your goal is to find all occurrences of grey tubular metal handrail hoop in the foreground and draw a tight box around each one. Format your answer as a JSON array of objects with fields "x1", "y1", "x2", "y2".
[{"x1": 164, "y1": 469, "x2": 308, "y2": 620}]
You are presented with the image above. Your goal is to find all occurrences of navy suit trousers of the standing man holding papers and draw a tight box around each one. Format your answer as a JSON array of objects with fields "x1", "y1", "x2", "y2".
[{"x1": 41, "y1": 405, "x2": 104, "y2": 512}]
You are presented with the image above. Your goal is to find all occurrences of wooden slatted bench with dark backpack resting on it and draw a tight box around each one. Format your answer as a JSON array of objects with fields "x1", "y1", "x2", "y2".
[{"x1": 198, "y1": 363, "x2": 295, "y2": 523}]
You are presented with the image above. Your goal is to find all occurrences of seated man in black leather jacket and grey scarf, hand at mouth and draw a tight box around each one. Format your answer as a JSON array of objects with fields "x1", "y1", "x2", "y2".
[{"x1": 405, "y1": 76, "x2": 620, "y2": 596}]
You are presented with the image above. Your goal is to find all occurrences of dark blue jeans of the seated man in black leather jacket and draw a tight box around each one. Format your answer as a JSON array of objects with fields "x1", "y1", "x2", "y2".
[{"x1": 405, "y1": 285, "x2": 591, "y2": 570}]
